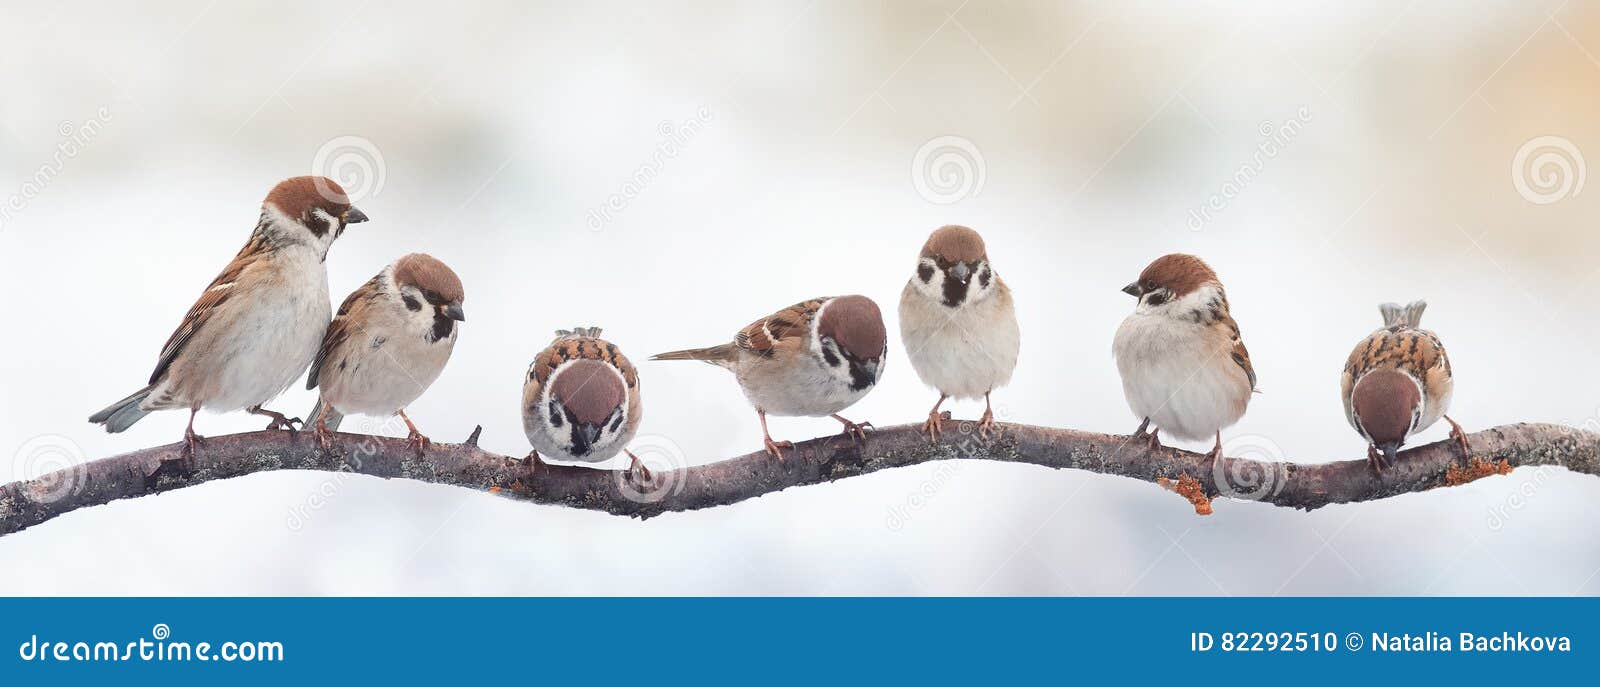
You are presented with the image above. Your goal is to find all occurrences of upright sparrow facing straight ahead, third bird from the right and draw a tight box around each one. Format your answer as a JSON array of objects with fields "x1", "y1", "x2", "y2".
[{"x1": 899, "y1": 224, "x2": 1022, "y2": 440}]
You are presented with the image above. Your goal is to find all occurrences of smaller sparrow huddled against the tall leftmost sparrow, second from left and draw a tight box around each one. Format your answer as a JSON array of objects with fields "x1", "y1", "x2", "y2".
[{"x1": 306, "y1": 253, "x2": 467, "y2": 452}]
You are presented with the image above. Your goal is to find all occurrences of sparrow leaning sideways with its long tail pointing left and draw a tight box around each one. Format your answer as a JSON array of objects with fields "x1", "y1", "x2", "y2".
[{"x1": 651, "y1": 296, "x2": 888, "y2": 460}]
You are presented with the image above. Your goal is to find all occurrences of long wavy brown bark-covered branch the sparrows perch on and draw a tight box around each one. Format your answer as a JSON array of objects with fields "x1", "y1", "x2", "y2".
[{"x1": 0, "y1": 421, "x2": 1600, "y2": 535}]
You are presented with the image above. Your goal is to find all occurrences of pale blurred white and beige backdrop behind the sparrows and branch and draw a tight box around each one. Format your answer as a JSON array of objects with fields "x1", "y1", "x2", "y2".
[{"x1": 0, "y1": 0, "x2": 1600, "y2": 594}]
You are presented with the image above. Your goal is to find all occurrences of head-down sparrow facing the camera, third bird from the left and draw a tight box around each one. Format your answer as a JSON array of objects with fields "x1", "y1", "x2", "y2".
[{"x1": 522, "y1": 327, "x2": 651, "y2": 480}]
